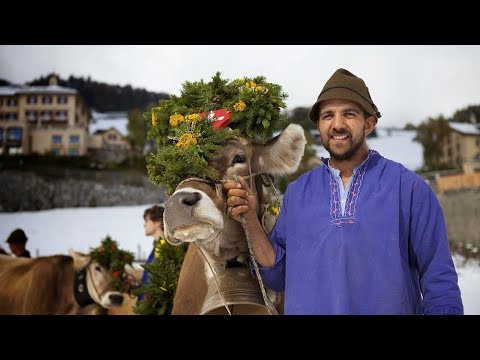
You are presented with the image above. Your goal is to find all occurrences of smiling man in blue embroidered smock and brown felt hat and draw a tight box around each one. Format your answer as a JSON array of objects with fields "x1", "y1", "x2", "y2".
[{"x1": 225, "y1": 69, "x2": 463, "y2": 314}]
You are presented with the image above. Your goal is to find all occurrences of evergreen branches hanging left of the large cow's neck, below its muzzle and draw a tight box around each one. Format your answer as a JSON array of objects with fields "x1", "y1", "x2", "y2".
[{"x1": 133, "y1": 239, "x2": 187, "y2": 315}]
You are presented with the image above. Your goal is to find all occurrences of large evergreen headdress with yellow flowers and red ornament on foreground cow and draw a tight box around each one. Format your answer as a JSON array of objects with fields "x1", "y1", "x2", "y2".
[{"x1": 144, "y1": 72, "x2": 287, "y2": 194}]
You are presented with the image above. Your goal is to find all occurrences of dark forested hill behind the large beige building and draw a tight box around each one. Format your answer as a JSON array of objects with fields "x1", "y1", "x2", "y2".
[{"x1": 28, "y1": 74, "x2": 170, "y2": 112}]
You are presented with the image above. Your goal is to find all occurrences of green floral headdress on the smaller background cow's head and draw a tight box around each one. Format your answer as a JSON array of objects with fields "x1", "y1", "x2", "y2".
[{"x1": 90, "y1": 235, "x2": 134, "y2": 291}]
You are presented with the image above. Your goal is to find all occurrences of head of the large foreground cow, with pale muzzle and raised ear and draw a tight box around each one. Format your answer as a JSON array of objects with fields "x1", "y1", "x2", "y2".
[{"x1": 164, "y1": 124, "x2": 306, "y2": 259}]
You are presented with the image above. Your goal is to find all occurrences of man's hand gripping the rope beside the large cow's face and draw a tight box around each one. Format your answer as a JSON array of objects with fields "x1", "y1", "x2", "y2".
[{"x1": 223, "y1": 177, "x2": 258, "y2": 221}]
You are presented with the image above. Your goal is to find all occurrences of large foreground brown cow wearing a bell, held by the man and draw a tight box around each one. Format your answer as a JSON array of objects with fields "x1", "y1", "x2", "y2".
[{"x1": 164, "y1": 124, "x2": 306, "y2": 314}]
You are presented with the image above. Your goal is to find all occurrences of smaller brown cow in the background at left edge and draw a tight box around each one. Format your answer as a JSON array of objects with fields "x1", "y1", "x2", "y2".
[{"x1": 0, "y1": 250, "x2": 123, "y2": 314}]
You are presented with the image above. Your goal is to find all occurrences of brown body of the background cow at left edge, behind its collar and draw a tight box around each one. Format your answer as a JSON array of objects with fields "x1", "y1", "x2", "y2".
[{"x1": 0, "y1": 255, "x2": 76, "y2": 314}]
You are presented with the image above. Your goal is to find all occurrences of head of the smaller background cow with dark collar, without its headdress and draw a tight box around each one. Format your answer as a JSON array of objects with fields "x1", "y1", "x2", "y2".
[{"x1": 68, "y1": 249, "x2": 123, "y2": 309}]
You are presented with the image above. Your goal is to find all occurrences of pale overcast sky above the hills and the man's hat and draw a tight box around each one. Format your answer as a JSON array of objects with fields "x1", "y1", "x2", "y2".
[{"x1": 0, "y1": 45, "x2": 480, "y2": 126}]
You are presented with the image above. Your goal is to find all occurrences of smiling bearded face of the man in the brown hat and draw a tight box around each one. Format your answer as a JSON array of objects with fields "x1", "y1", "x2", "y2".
[{"x1": 317, "y1": 100, "x2": 375, "y2": 161}]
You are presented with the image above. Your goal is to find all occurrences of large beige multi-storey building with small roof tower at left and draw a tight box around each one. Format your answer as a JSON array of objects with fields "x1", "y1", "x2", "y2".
[{"x1": 0, "y1": 75, "x2": 90, "y2": 156}]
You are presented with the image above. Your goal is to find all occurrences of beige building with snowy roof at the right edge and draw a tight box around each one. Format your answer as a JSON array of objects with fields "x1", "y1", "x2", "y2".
[{"x1": 440, "y1": 122, "x2": 480, "y2": 172}]
